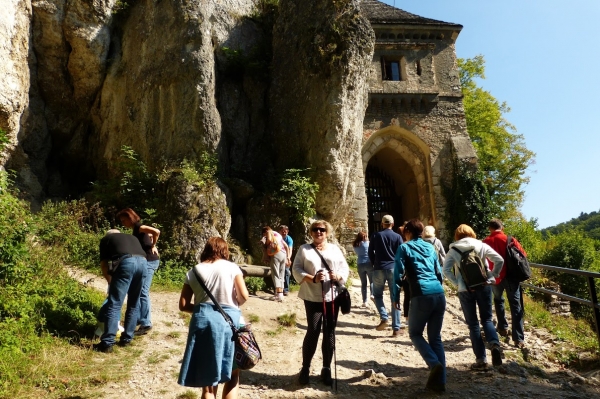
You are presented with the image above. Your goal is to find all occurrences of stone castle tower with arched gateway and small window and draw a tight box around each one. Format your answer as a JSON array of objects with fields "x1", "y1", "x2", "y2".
[{"x1": 340, "y1": 0, "x2": 476, "y2": 247}]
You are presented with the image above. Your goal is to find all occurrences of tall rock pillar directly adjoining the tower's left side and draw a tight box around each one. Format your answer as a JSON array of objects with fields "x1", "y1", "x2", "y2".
[{"x1": 271, "y1": 0, "x2": 374, "y2": 226}]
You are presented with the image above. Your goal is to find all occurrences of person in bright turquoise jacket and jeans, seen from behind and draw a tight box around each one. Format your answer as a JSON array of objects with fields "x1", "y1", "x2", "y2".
[{"x1": 394, "y1": 219, "x2": 446, "y2": 392}]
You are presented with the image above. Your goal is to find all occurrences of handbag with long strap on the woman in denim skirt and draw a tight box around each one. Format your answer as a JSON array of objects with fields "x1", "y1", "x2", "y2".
[{"x1": 192, "y1": 267, "x2": 262, "y2": 370}]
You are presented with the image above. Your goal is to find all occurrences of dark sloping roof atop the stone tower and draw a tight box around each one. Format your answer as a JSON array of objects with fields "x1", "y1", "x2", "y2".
[{"x1": 360, "y1": 0, "x2": 462, "y2": 29}]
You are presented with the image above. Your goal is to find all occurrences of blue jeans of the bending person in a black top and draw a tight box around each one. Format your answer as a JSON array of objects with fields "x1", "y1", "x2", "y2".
[{"x1": 100, "y1": 256, "x2": 147, "y2": 346}]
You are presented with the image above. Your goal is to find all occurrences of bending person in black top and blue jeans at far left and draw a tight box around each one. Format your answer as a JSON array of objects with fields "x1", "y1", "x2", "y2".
[{"x1": 93, "y1": 229, "x2": 148, "y2": 352}]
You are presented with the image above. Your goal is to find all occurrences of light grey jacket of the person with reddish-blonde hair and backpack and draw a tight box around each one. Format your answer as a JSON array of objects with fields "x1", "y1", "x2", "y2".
[{"x1": 444, "y1": 237, "x2": 504, "y2": 292}]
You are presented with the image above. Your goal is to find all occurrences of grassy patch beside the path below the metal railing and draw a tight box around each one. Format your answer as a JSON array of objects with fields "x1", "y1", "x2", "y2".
[{"x1": 523, "y1": 295, "x2": 600, "y2": 366}]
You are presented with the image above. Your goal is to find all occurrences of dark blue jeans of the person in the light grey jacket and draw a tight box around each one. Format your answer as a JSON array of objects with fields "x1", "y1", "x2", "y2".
[{"x1": 458, "y1": 285, "x2": 500, "y2": 362}]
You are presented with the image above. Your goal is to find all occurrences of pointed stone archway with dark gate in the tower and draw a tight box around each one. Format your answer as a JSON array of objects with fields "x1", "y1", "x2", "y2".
[{"x1": 362, "y1": 126, "x2": 437, "y2": 234}]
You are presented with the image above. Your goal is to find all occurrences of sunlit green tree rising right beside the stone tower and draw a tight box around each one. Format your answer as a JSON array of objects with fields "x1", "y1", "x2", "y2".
[{"x1": 458, "y1": 55, "x2": 535, "y2": 219}]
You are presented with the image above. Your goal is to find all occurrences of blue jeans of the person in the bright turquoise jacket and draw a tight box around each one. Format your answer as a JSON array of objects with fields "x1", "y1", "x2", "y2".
[{"x1": 408, "y1": 293, "x2": 446, "y2": 384}]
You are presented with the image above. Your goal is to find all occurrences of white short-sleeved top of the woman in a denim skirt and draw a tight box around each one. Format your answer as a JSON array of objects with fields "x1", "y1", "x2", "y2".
[{"x1": 183, "y1": 259, "x2": 242, "y2": 308}]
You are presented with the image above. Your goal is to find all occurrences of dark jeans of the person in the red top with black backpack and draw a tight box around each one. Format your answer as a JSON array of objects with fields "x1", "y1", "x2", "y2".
[{"x1": 492, "y1": 279, "x2": 525, "y2": 343}]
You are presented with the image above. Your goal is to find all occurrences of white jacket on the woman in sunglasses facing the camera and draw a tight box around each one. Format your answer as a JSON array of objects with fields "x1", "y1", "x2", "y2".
[{"x1": 292, "y1": 243, "x2": 350, "y2": 302}]
